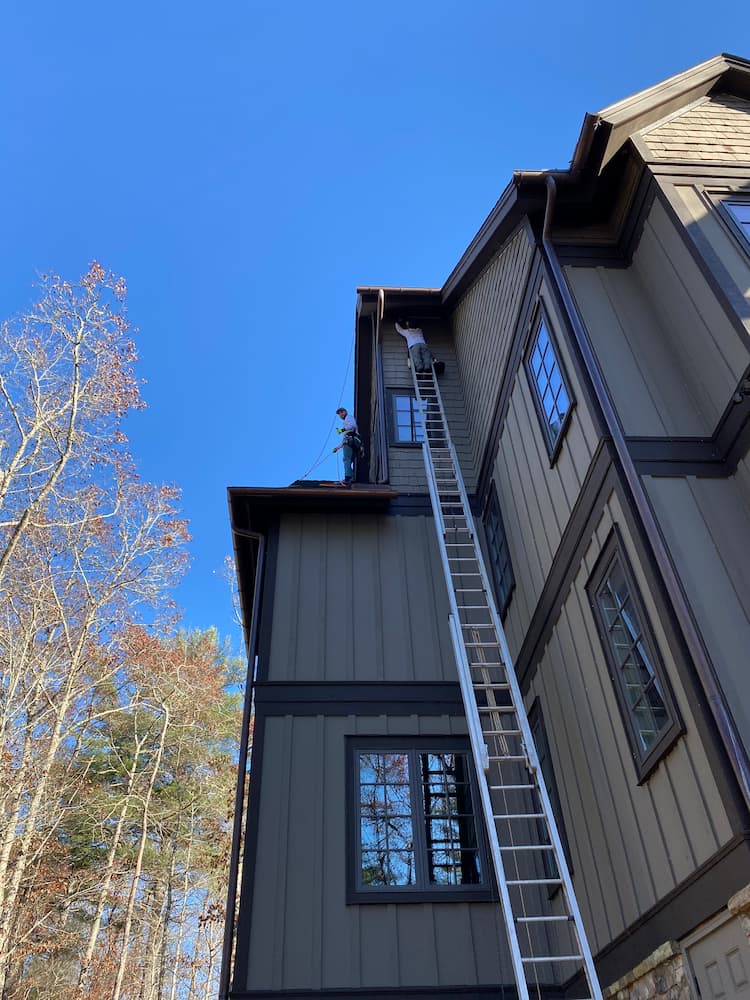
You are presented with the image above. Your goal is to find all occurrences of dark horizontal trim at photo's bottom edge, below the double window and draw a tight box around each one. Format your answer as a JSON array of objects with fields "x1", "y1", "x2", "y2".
[{"x1": 229, "y1": 983, "x2": 544, "y2": 1000}]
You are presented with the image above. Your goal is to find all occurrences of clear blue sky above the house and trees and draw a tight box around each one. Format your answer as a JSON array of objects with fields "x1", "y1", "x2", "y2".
[{"x1": 0, "y1": 0, "x2": 750, "y2": 640}]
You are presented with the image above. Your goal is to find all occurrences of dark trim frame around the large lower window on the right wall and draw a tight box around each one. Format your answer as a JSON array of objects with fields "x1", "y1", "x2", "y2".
[{"x1": 586, "y1": 524, "x2": 685, "y2": 785}]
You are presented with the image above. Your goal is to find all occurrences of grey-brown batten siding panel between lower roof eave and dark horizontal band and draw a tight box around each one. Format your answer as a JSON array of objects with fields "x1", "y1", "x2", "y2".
[{"x1": 270, "y1": 513, "x2": 457, "y2": 682}]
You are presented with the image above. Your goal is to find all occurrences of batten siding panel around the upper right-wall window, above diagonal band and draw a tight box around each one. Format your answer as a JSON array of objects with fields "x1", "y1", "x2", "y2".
[{"x1": 493, "y1": 282, "x2": 599, "y2": 655}]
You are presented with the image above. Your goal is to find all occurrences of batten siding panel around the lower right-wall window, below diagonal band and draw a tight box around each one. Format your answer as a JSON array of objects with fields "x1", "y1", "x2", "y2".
[{"x1": 527, "y1": 492, "x2": 733, "y2": 953}]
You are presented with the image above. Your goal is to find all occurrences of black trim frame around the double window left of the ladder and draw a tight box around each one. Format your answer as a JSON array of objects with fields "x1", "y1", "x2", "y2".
[{"x1": 345, "y1": 734, "x2": 498, "y2": 905}]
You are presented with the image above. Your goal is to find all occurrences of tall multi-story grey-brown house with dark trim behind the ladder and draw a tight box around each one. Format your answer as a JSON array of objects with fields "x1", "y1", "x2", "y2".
[{"x1": 225, "y1": 55, "x2": 750, "y2": 1000}]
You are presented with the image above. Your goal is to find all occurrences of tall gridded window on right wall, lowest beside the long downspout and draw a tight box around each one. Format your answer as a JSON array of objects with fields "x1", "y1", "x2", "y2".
[{"x1": 588, "y1": 529, "x2": 681, "y2": 780}]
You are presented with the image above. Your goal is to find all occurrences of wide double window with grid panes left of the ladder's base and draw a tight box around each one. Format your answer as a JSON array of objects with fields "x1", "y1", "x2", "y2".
[{"x1": 349, "y1": 737, "x2": 489, "y2": 902}]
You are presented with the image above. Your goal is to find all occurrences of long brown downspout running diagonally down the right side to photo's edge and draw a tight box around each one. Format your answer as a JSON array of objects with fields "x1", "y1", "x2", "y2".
[{"x1": 542, "y1": 174, "x2": 750, "y2": 808}]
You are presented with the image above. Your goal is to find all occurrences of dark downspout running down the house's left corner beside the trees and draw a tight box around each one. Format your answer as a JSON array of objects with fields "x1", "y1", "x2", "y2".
[{"x1": 219, "y1": 526, "x2": 266, "y2": 1000}]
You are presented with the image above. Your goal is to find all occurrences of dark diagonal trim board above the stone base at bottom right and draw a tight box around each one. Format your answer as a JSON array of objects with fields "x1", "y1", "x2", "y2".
[{"x1": 592, "y1": 832, "x2": 750, "y2": 996}]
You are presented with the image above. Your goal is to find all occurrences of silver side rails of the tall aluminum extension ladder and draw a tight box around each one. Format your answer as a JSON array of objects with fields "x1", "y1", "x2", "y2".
[{"x1": 412, "y1": 368, "x2": 601, "y2": 1000}]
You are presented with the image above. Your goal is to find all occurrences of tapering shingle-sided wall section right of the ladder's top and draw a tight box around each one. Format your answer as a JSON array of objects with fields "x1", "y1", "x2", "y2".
[{"x1": 452, "y1": 229, "x2": 534, "y2": 480}]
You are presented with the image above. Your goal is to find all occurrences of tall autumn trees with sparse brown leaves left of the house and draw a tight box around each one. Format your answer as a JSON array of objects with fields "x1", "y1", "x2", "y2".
[{"x1": 0, "y1": 263, "x2": 239, "y2": 1000}]
